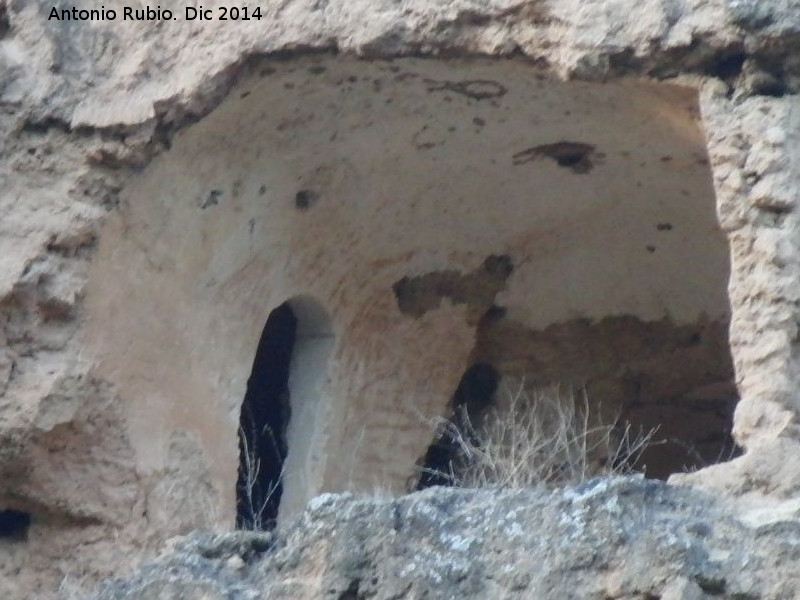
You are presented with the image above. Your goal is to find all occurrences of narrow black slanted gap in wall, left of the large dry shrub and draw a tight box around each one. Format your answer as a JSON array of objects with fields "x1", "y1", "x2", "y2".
[{"x1": 416, "y1": 363, "x2": 500, "y2": 490}]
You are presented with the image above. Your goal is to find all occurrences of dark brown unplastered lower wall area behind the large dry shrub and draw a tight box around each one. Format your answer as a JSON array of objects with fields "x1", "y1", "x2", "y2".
[{"x1": 444, "y1": 311, "x2": 741, "y2": 487}]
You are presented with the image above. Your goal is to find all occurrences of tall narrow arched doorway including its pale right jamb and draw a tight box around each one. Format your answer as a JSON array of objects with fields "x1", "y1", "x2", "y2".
[{"x1": 236, "y1": 297, "x2": 334, "y2": 529}]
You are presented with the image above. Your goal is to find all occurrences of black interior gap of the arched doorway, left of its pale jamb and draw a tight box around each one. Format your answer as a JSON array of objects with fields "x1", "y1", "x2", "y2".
[{"x1": 236, "y1": 303, "x2": 297, "y2": 529}]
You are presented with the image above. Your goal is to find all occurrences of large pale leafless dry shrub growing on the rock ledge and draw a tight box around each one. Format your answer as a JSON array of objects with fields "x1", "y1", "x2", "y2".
[{"x1": 422, "y1": 385, "x2": 655, "y2": 489}]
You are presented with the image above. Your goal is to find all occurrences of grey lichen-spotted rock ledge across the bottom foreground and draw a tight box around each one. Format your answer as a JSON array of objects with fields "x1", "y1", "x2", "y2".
[{"x1": 96, "y1": 479, "x2": 800, "y2": 600}]
